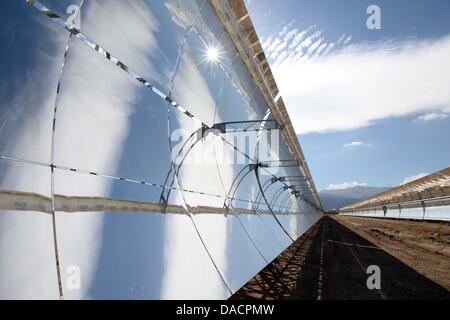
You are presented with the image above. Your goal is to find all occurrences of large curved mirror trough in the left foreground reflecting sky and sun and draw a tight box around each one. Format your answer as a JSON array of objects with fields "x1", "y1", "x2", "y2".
[{"x1": 0, "y1": 0, "x2": 320, "y2": 299}]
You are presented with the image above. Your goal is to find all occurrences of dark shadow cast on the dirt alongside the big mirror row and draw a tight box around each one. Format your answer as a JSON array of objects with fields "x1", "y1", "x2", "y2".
[{"x1": 230, "y1": 216, "x2": 450, "y2": 300}]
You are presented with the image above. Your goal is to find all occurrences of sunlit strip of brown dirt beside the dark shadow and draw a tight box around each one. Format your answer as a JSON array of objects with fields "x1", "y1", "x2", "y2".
[{"x1": 333, "y1": 215, "x2": 450, "y2": 290}]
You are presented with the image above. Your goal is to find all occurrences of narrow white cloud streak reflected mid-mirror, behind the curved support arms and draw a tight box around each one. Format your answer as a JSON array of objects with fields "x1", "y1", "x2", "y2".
[{"x1": 162, "y1": 38, "x2": 233, "y2": 298}]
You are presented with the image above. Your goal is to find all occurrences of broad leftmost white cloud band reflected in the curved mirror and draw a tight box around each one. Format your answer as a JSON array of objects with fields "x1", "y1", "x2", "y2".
[{"x1": 0, "y1": 1, "x2": 162, "y2": 298}]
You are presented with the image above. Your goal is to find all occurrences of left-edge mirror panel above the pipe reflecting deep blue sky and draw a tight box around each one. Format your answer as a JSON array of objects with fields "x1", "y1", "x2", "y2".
[{"x1": 0, "y1": 13, "x2": 68, "y2": 163}]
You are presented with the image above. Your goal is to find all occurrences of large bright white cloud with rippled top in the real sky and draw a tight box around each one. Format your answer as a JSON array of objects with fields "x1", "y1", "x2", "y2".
[{"x1": 266, "y1": 27, "x2": 450, "y2": 134}]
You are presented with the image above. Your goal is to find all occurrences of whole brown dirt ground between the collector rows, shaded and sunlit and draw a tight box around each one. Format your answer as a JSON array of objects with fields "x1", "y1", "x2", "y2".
[{"x1": 231, "y1": 216, "x2": 450, "y2": 300}]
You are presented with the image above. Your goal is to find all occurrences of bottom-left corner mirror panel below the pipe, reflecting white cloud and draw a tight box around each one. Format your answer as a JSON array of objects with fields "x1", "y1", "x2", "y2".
[{"x1": 0, "y1": 211, "x2": 58, "y2": 299}]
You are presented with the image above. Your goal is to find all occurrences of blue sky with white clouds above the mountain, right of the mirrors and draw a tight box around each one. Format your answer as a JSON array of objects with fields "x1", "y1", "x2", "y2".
[{"x1": 246, "y1": 0, "x2": 450, "y2": 190}]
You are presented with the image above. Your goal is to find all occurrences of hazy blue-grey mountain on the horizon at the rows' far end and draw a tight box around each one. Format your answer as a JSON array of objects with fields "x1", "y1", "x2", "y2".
[{"x1": 319, "y1": 186, "x2": 389, "y2": 211}]
